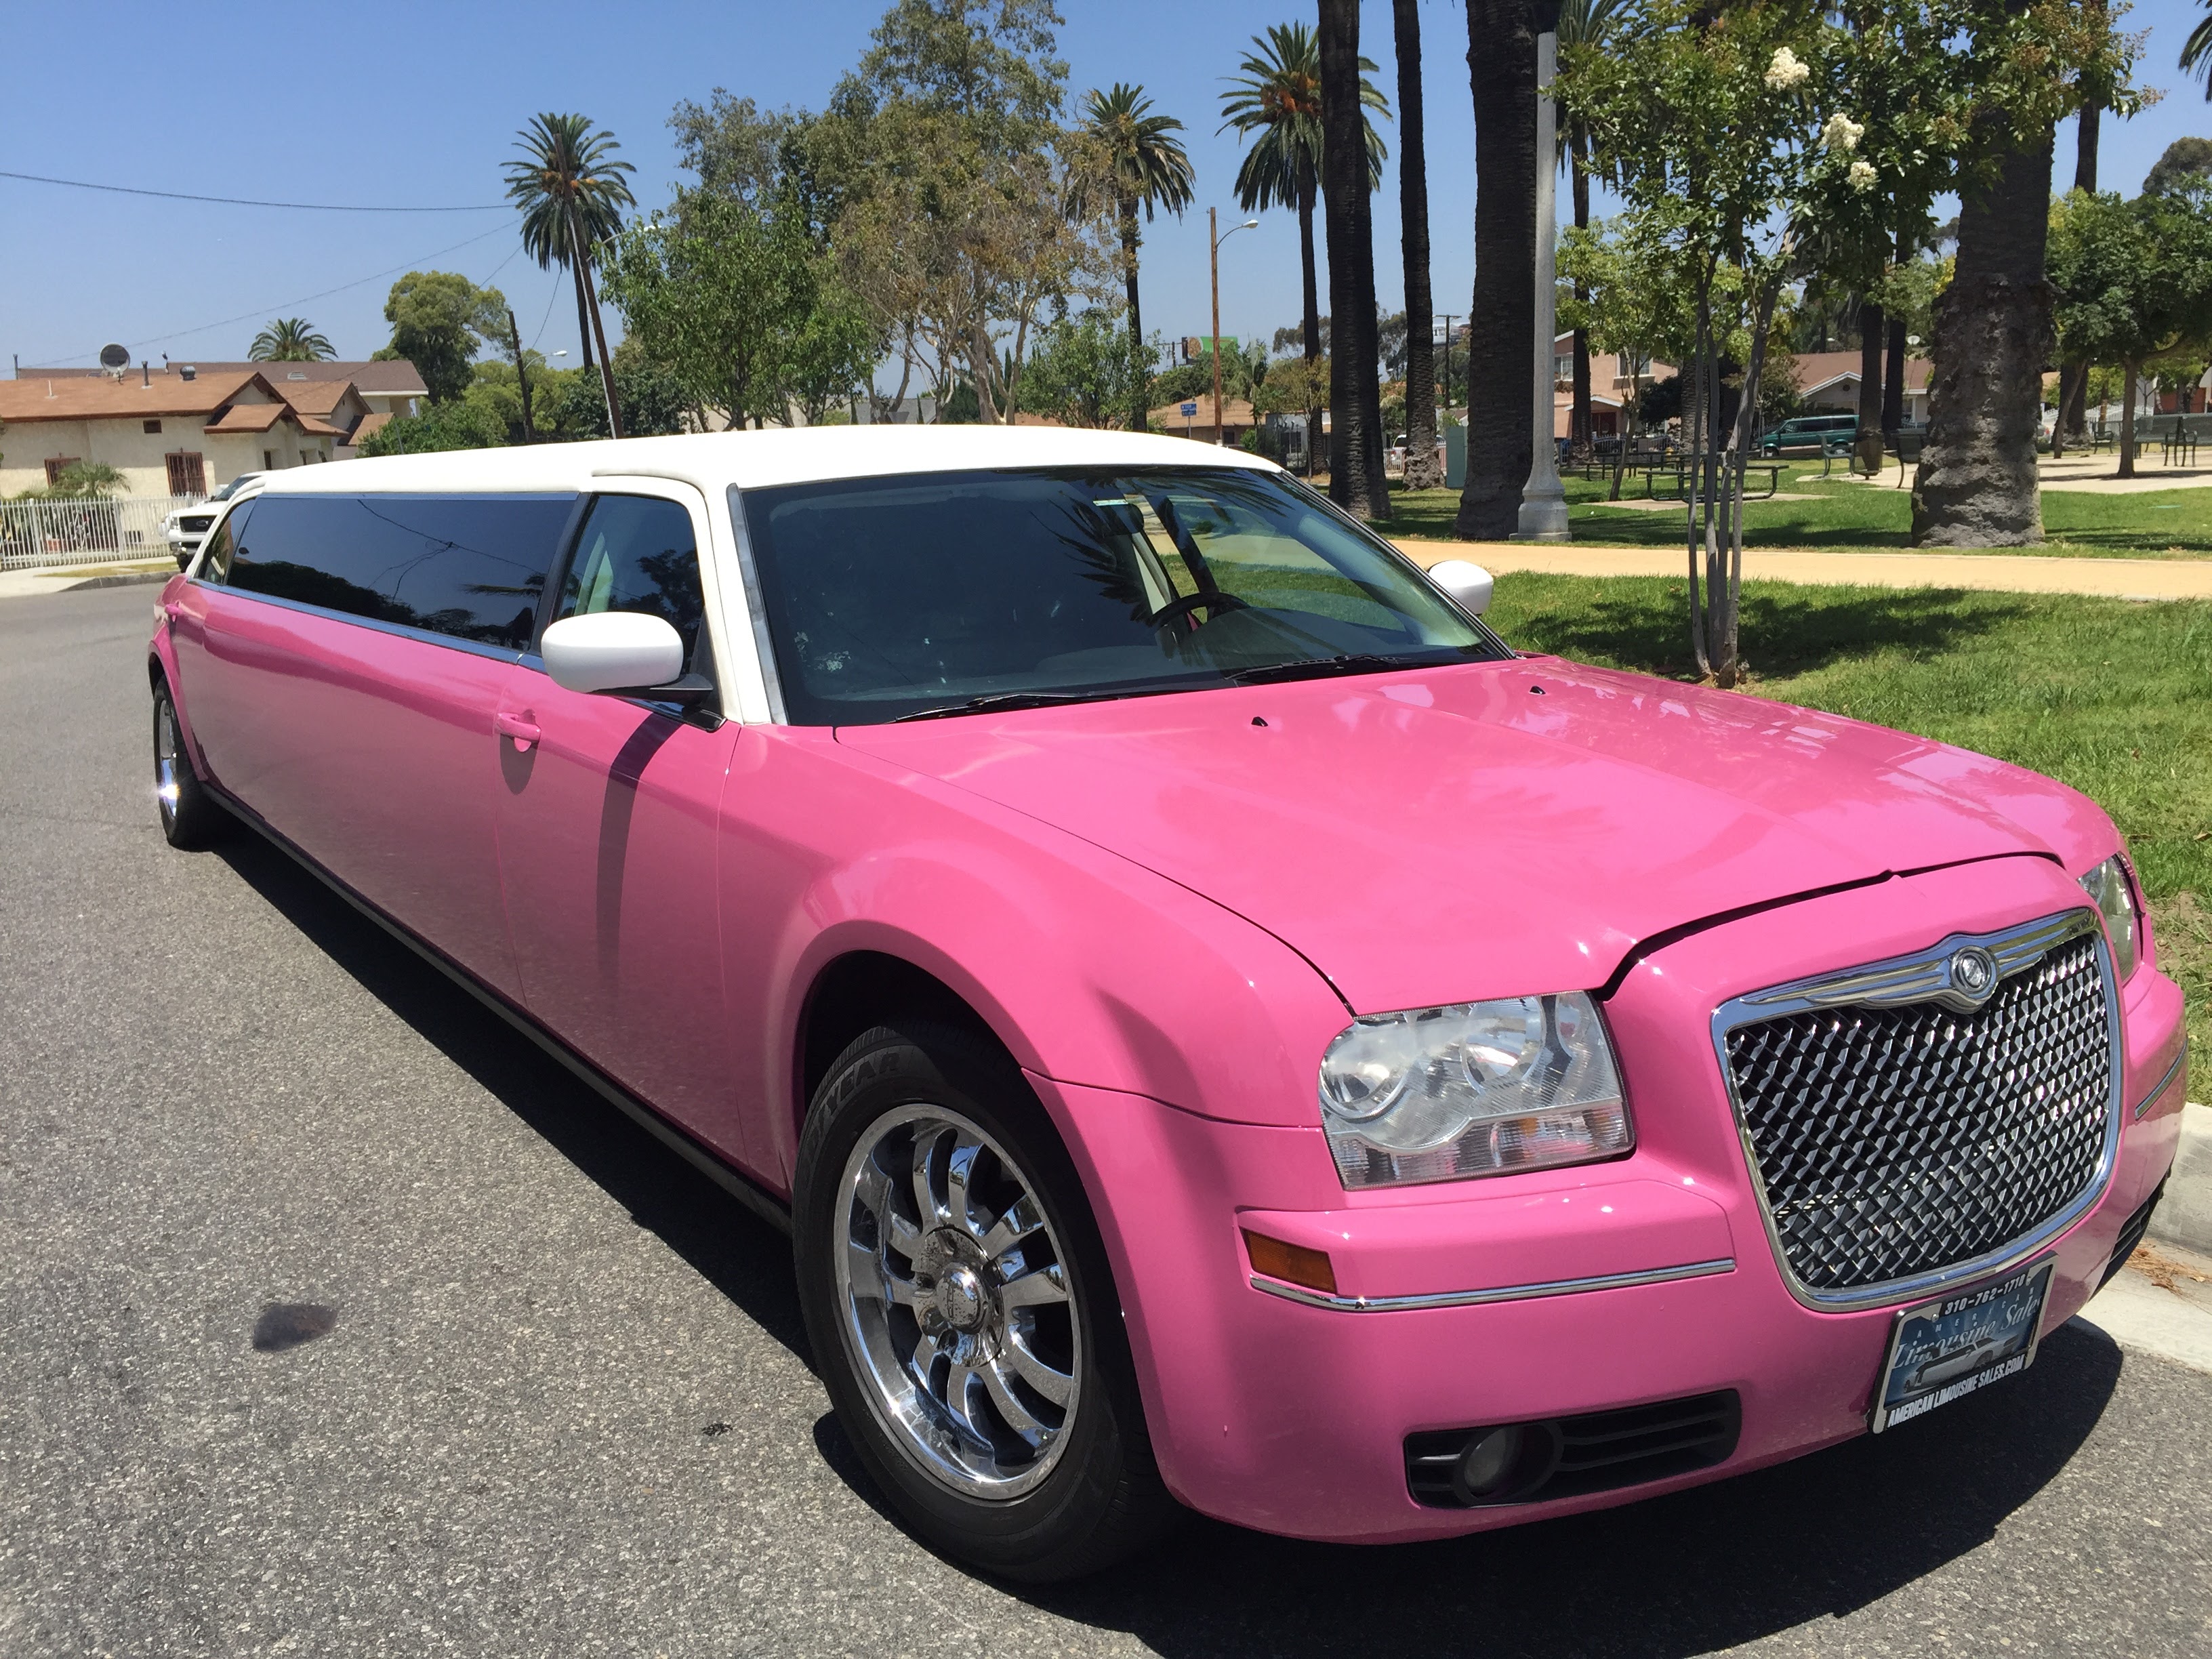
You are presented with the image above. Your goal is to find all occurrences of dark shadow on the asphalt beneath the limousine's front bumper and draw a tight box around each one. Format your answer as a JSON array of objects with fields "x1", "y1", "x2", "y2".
[{"x1": 1017, "y1": 1323, "x2": 2121, "y2": 1659}]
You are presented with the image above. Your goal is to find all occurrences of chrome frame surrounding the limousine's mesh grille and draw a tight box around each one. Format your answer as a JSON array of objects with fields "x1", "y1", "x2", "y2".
[{"x1": 1712, "y1": 907, "x2": 2128, "y2": 1314}]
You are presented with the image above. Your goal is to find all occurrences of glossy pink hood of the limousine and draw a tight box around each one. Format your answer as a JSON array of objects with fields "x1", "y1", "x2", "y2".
[{"x1": 838, "y1": 659, "x2": 2114, "y2": 1013}]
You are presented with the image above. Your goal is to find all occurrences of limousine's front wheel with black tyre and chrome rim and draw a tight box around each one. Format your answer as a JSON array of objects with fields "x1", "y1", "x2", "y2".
[{"x1": 792, "y1": 1024, "x2": 1174, "y2": 1582}]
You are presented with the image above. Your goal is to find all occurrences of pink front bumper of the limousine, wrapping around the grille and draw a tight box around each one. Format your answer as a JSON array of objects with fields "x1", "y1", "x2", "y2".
[{"x1": 1033, "y1": 858, "x2": 2186, "y2": 1542}]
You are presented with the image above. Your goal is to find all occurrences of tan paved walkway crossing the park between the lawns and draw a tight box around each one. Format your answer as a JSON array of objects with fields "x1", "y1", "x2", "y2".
[{"x1": 1398, "y1": 539, "x2": 2212, "y2": 600}]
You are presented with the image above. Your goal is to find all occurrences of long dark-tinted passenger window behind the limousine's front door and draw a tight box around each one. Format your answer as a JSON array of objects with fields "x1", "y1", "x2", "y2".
[{"x1": 230, "y1": 495, "x2": 573, "y2": 651}]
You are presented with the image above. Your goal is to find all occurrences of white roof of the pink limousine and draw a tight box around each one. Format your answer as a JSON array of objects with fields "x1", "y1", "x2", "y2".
[{"x1": 254, "y1": 427, "x2": 1279, "y2": 495}]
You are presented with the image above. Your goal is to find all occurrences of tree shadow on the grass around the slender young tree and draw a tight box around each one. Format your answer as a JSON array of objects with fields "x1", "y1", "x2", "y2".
[{"x1": 1507, "y1": 577, "x2": 2039, "y2": 679}]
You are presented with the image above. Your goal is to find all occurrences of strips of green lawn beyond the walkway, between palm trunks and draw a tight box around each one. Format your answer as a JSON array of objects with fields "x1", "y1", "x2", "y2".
[{"x1": 1387, "y1": 462, "x2": 2212, "y2": 560}]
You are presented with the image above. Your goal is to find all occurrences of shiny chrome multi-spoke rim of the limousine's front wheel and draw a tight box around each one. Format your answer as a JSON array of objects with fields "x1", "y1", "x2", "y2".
[{"x1": 832, "y1": 1104, "x2": 1082, "y2": 1500}]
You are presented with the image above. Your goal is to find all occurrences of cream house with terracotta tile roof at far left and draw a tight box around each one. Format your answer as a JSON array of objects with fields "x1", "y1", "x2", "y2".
[{"x1": 0, "y1": 365, "x2": 359, "y2": 497}]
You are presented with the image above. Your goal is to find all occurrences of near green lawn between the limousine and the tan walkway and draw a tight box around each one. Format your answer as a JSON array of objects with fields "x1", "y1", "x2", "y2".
[{"x1": 1489, "y1": 575, "x2": 2212, "y2": 1066}]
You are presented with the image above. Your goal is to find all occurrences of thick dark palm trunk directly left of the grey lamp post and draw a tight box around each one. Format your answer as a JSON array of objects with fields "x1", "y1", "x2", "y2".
[{"x1": 1451, "y1": 0, "x2": 1535, "y2": 542}]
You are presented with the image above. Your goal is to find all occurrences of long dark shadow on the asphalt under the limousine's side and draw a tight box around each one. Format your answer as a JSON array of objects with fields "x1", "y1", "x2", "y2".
[{"x1": 217, "y1": 825, "x2": 807, "y2": 1360}]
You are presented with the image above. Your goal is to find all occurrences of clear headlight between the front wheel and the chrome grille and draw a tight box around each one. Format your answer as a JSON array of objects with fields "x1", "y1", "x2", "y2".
[{"x1": 1321, "y1": 991, "x2": 1637, "y2": 1188}]
